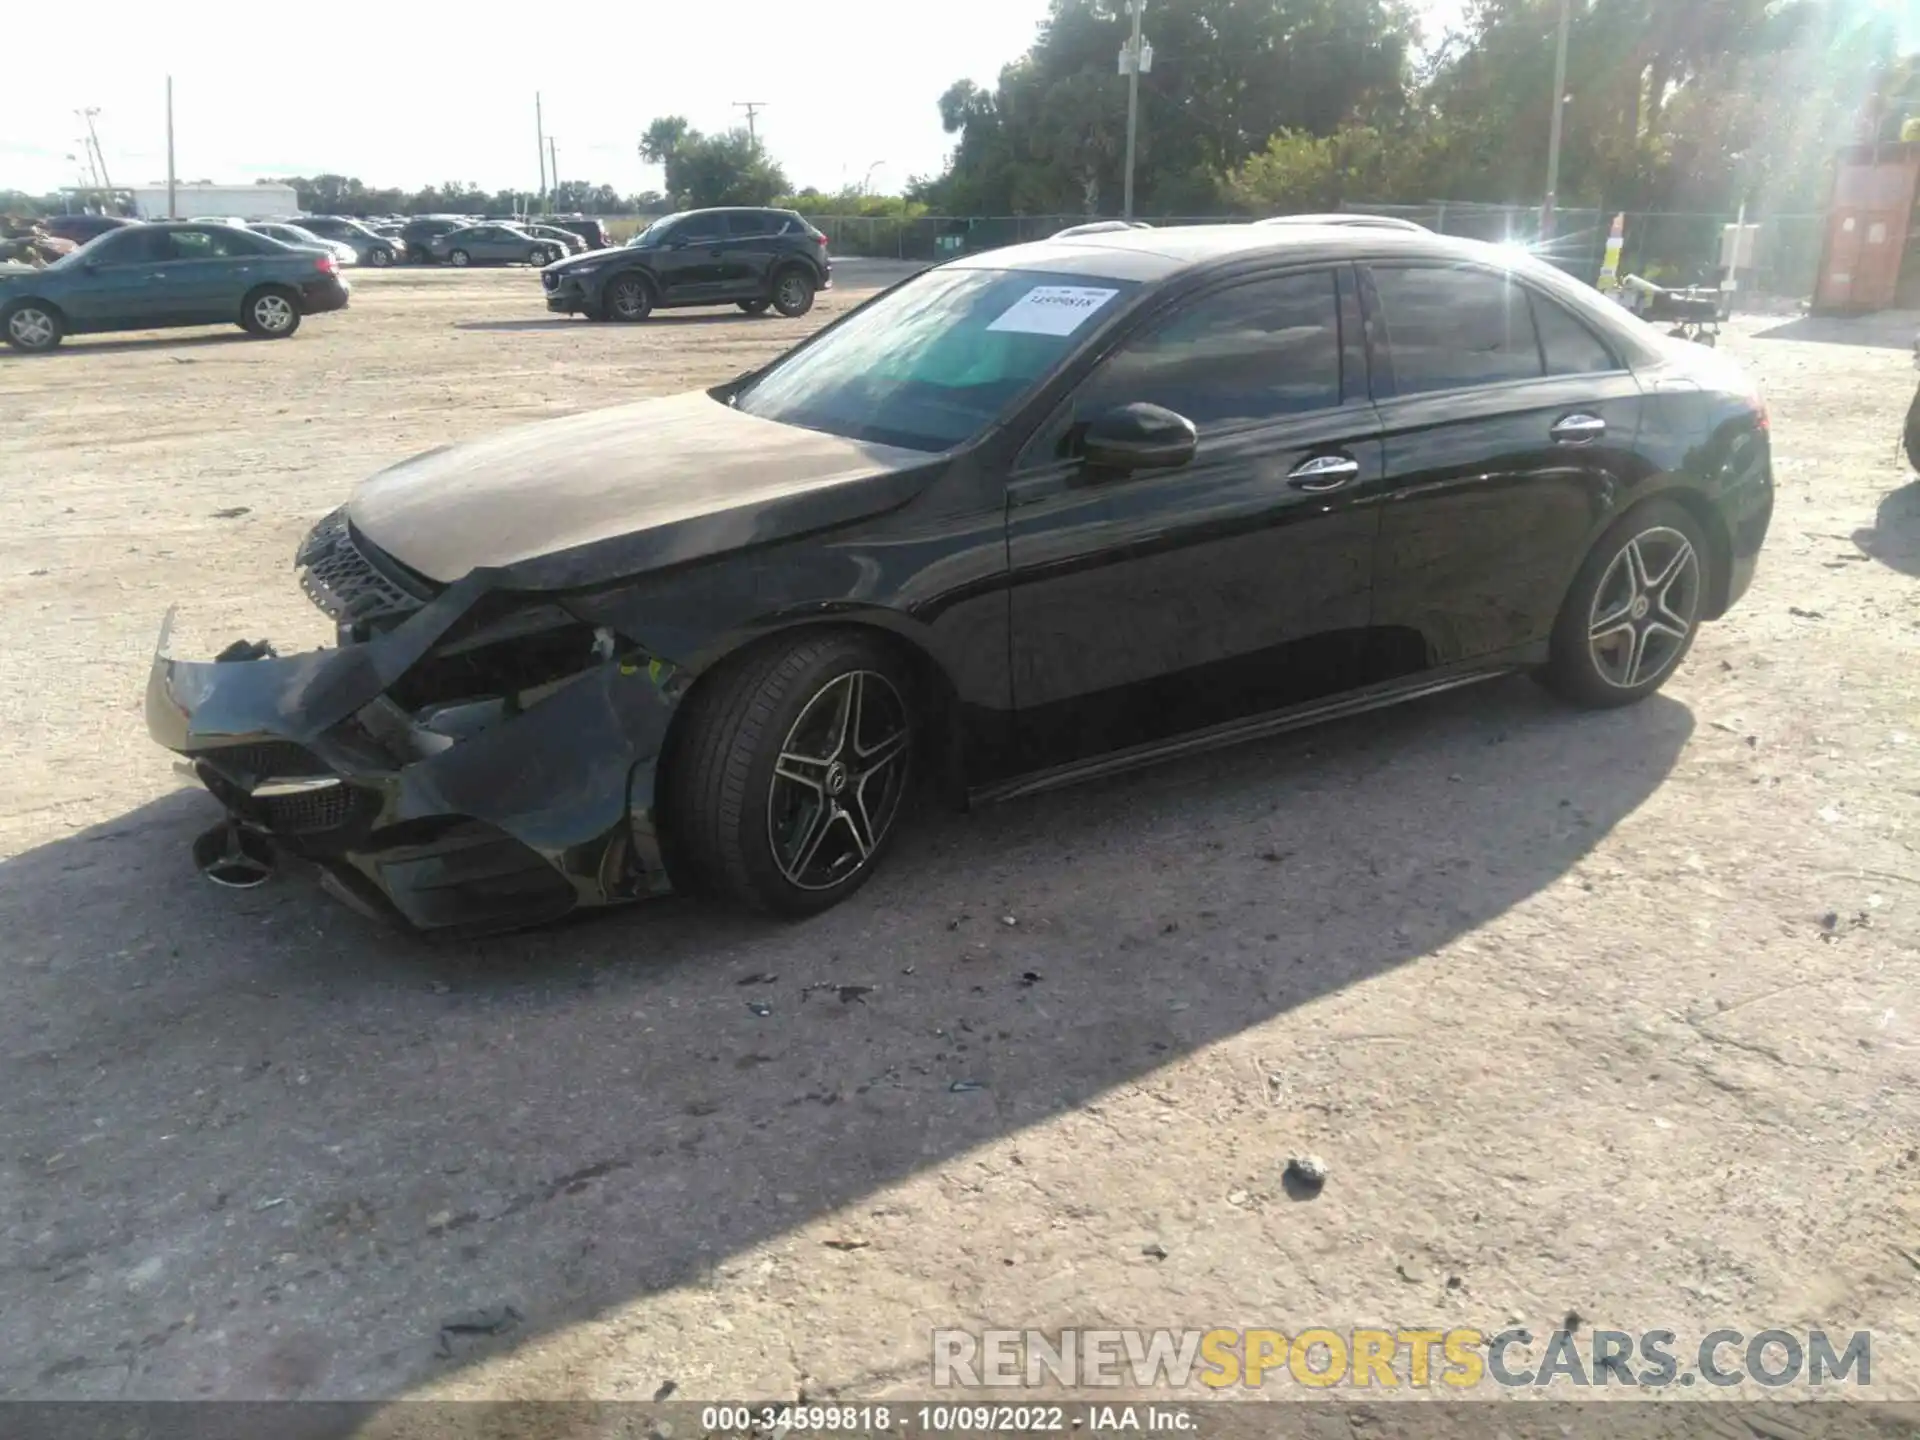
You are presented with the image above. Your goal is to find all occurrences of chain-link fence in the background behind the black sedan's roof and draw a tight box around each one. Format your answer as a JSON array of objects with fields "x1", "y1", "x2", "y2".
[{"x1": 791, "y1": 200, "x2": 1826, "y2": 298}]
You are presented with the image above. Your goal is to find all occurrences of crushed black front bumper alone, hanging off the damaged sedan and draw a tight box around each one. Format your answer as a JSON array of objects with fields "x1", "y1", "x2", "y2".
[{"x1": 146, "y1": 580, "x2": 678, "y2": 933}]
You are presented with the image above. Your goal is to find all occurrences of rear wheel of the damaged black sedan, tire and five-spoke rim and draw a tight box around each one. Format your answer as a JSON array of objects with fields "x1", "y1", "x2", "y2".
[{"x1": 1542, "y1": 501, "x2": 1709, "y2": 710}]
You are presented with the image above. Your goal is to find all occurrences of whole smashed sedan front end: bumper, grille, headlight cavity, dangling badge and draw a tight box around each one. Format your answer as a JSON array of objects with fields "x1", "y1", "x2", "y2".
[{"x1": 146, "y1": 516, "x2": 689, "y2": 933}]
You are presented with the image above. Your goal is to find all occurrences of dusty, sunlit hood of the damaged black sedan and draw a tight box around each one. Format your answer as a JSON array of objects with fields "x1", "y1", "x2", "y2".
[{"x1": 348, "y1": 392, "x2": 933, "y2": 586}]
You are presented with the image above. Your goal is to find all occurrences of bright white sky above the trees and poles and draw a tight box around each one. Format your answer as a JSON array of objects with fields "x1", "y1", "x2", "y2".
[{"x1": 0, "y1": 0, "x2": 1920, "y2": 204}]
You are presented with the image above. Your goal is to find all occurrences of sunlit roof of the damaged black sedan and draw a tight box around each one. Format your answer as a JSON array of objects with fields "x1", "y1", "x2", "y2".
[{"x1": 948, "y1": 225, "x2": 1559, "y2": 282}]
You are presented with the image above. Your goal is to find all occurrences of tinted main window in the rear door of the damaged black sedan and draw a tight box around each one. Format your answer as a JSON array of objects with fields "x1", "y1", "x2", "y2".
[{"x1": 1373, "y1": 267, "x2": 1542, "y2": 396}]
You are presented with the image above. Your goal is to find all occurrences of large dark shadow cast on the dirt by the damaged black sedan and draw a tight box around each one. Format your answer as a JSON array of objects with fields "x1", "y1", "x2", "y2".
[{"x1": 0, "y1": 680, "x2": 1693, "y2": 1398}]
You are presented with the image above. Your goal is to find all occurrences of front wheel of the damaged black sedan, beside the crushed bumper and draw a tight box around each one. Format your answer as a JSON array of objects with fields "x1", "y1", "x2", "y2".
[{"x1": 664, "y1": 632, "x2": 914, "y2": 916}]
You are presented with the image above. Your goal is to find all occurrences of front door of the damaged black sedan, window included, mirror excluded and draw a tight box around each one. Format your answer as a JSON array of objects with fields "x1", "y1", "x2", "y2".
[{"x1": 1008, "y1": 267, "x2": 1382, "y2": 768}]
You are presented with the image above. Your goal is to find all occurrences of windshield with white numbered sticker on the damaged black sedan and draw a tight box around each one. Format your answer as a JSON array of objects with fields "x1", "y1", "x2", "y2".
[{"x1": 735, "y1": 271, "x2": 1139, "y2": 451}]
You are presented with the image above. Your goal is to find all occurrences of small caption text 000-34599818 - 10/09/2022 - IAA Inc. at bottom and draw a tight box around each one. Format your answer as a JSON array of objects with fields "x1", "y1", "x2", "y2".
[{"x1": 701, "y1": 1404, "x2": 1196, "y2": 1436}]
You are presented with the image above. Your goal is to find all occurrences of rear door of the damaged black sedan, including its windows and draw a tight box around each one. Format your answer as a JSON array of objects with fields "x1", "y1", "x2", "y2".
[{"x1": 1361, "y1": 261, "x2": 1640, "y2": 680}]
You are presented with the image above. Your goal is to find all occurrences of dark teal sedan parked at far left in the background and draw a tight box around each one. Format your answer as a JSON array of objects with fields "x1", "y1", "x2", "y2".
[{"x1": 0, "y1": 221, "x2": 348, "y2": 351}]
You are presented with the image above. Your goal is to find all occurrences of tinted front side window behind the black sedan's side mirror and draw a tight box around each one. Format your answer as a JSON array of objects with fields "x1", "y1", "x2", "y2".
[{"x1": 1073, "y1": 271, "x2": 1340, "y2": 432}]
